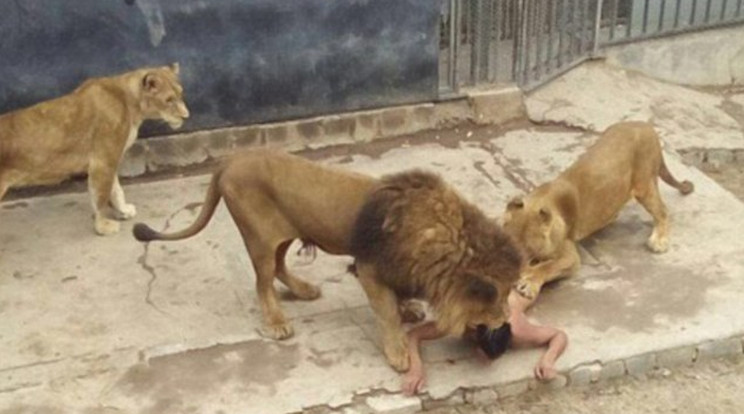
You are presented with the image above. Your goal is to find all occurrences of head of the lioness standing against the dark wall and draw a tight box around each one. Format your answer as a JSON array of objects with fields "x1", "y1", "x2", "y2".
[{"x1": 140, "y1": 63, "x2": 189, "y2": 129}]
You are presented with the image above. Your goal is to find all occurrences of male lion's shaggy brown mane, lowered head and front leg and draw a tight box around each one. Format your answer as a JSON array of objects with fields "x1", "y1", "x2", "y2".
[{"x1": 351, "y1": 171, "x2": 522, "y2": 371}]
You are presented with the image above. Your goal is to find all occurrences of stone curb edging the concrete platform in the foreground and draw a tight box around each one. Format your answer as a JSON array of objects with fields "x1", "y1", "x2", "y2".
[{"x1": 292, "y1": 332, "x2": 744, "y2": 414}]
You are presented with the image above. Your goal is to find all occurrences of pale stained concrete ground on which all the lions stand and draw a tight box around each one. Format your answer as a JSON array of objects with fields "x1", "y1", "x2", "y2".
[{"x1": 0, "y1": 63, "x2": 744, "y2": 414}]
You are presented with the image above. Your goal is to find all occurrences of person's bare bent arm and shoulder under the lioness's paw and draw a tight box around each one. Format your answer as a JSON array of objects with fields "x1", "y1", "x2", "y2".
[{"x1": 509, "y1": 292, "x2": 568, "y2": 380}]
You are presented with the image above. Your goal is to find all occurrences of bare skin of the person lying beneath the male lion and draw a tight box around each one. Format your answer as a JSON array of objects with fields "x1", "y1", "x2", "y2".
[{"x1": 402, "y1": 291, "x2": 568, "y2": 395}]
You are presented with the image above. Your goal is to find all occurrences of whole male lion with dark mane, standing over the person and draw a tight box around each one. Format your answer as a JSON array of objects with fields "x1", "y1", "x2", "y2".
[{"x1": 133, "y1": 149, "x2": 519, "y2": 371}]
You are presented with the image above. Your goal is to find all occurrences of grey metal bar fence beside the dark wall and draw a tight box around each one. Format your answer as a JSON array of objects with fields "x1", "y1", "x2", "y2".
[{"x1": 439, "y1": 0, "x2": 744, "y2": 95}]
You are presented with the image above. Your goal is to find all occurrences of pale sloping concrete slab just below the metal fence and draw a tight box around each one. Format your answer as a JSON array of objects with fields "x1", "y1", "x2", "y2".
[{"x1": 525, "y1": 62, "x2": 744, "y2": 150}]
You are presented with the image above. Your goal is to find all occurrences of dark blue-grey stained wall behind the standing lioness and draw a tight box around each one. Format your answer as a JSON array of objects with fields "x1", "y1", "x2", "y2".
[{"x1": 0, "y1": 0, "x2": 440, "y2": 135}]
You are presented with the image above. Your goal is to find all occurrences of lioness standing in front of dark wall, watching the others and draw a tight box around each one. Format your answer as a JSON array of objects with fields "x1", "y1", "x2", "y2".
[{"x1": 0, "y1": 63, "x2": 189, "y2": 235}]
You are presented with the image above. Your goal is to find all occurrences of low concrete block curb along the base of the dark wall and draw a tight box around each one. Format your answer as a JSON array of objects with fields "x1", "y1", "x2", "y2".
[{"x1": 119, "y1": 86, "x2": 526, "y2": 177}]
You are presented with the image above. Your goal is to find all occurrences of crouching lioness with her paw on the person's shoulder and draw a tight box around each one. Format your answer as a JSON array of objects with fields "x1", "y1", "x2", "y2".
[{"x1": 502, "y1": 122, "x2": 694, "y2": 299}]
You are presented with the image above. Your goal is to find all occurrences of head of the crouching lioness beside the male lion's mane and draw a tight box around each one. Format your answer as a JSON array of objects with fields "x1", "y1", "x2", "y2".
[{"x1": 502, "y1": 197, "x2": 568, "y2": 266}]
